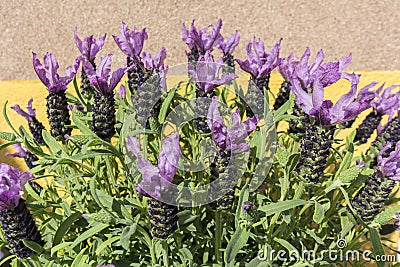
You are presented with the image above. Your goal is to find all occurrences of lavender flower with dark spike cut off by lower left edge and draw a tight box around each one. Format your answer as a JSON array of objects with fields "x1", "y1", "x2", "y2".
[{"x1": 0, "y1": 163, "x2": 44, "y2": 258}]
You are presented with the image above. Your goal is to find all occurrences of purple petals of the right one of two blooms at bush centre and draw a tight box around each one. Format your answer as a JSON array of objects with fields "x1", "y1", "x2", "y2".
[{"x1": 207, "y1": 96, "x2": 258, "y2": 153}]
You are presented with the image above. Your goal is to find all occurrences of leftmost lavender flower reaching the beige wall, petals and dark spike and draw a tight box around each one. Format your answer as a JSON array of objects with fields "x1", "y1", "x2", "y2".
[{"x1": 33, "y1": 53, "x2": 81, "y2": 140}]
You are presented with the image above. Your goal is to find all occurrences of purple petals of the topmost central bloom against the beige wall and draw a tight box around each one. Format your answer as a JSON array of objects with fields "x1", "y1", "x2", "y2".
[{"x1": 182, "y1": 19, "x2": 224, "y2": 54}]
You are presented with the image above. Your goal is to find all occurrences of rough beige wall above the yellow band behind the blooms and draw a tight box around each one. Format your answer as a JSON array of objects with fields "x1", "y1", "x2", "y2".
[{"x1": 0, "y1": 0, "x2": 400, "y2": 80}]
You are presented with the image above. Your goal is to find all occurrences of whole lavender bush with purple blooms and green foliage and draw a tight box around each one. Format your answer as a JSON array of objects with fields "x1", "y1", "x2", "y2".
[{"x1": 0, "y1": 20, "x2": 400, "y2": 267}]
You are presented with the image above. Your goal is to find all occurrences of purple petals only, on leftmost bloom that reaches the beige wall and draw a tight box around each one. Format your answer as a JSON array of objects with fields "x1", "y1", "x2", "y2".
[{"x1": 32, "y1": 52, "x2": 81, "y2": 92}]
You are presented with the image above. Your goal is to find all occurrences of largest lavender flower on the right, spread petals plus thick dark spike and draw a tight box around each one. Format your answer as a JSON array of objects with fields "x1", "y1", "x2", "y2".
[{"x1": 291, "y1": 70, "x2": 372, "y2": 183}]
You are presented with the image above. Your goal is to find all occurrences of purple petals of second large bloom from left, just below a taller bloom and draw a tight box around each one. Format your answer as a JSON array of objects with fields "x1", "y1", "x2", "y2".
[{"x1": 83, "y1": 54, "x2": 127, "y2": 93}]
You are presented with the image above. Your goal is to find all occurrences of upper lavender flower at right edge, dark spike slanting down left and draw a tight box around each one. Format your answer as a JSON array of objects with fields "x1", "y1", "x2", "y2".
[{"x1": 355, "y1": 84, "x2": 400, "y2": 144}]
